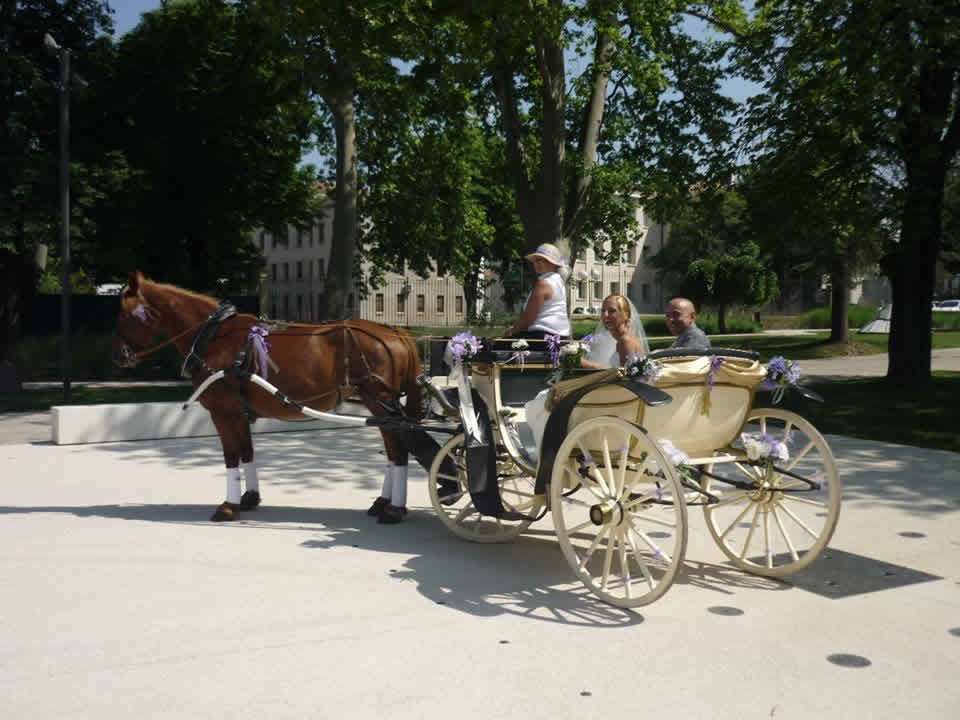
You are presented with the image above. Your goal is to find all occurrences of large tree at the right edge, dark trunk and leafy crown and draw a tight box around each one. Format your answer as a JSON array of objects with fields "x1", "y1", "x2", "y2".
[{"x1": 744, "y1": 0, "x2": 960, "y2": 383}]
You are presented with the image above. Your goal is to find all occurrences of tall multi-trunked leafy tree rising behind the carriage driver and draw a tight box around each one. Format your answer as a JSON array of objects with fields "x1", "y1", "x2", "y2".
[{"x1": 438, "y1": 0, "x2": 740, "y2": 268}]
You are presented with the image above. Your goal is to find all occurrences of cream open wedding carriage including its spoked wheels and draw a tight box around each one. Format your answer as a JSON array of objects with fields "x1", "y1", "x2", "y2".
[{"x1": 430, "y1": 350, "x2": 840, "y2": 607}]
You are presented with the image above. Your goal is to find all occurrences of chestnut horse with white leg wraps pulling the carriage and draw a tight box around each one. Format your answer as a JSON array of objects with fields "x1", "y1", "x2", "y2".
[{"x1": 115, "y1": 271, "x2": 421, "y2": 523}]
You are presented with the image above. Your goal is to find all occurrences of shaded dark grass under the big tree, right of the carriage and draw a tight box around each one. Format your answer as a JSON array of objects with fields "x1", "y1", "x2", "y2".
[{"x1": 757, "y1": 372, "x2": 960, "y2": 452}]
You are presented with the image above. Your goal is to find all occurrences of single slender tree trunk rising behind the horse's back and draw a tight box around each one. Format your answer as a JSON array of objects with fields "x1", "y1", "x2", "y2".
[{"x1": 319, "y1": 86, "x2": 359, "y2": 319}]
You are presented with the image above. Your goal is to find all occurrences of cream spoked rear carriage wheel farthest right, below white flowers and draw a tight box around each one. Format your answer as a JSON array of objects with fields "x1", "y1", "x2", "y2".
[{"x1": 701, "y1": 408, "x2": 842, "y2": 577}]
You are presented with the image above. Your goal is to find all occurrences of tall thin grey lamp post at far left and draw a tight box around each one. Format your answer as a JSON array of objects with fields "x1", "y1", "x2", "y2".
[{"x1": 43, "y1": 33, "x2": 72, "y2": 403}]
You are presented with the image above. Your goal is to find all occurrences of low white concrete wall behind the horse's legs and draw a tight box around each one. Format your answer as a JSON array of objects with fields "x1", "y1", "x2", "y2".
[{"x1": 50, "y1": 403, "x2": 352, "y2": 445}]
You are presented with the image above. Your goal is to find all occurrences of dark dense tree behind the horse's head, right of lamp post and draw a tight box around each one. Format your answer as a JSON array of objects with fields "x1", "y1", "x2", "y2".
[{"x1": 91, "y1": 0, "x2": 316, "y2": 292}]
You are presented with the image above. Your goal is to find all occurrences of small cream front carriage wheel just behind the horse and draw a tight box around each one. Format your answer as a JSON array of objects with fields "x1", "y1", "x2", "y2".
[{"x1": 427, "y1": 433, "x2": 542, "y2": 543}]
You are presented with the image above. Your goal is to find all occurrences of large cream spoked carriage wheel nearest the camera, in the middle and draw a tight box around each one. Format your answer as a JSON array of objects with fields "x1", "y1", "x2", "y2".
[{"x1": 550, "y1": 416, "x2": 687, "y2": 607}]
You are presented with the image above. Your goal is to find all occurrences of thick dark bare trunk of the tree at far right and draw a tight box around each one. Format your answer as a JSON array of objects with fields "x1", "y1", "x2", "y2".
[{"x1": 887, "y1": 163, "x2": 946, "y2": 384}]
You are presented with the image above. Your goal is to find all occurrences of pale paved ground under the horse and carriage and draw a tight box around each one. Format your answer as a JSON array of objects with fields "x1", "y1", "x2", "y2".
[{"x1": 0, "y1": 424, "x2": 960, "y2": 720}]
